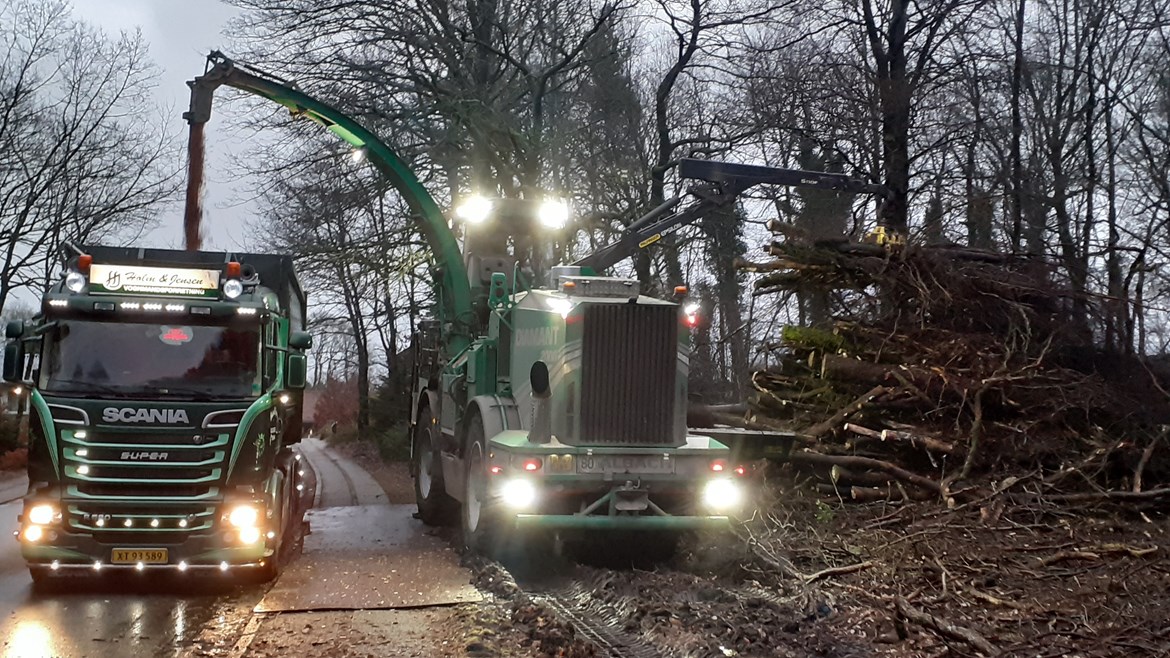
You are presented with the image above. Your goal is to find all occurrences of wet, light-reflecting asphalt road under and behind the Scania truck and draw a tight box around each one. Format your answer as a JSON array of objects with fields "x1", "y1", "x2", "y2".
[{"x1": 0, "y1": 440, "x2": 380, "y2": 658}]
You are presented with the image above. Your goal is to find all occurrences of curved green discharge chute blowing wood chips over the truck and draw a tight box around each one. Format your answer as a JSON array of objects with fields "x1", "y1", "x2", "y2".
[{"x1": 183, "y1": 50, "x2": 475, "y2": 355}]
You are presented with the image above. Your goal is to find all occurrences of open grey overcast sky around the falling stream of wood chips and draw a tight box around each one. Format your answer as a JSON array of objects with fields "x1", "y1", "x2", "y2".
[{"x1": 70, "y1": 0, "x2": 252, "y2": 249}]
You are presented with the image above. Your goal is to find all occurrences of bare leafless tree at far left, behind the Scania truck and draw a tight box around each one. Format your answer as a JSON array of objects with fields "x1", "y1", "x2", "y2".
[{"x1": 0, "y1": 0, "x2": 178, "y2": 306}]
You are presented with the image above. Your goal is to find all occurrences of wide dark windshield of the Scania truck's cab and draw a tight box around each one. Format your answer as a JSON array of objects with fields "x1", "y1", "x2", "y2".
[{"x1": 41, "y1": 321, "x2": 260, "y2": 398}]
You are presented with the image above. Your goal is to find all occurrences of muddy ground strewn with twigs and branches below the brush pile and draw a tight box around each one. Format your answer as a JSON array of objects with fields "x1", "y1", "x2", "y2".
[{"x1": 322, "y1": 444, "x2": 1170, "y2": 658}]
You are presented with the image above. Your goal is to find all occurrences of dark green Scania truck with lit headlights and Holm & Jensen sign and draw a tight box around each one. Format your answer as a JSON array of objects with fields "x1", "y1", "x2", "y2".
[{"x1": 4, "y1": 245, "x2": 312, "y2": 582}]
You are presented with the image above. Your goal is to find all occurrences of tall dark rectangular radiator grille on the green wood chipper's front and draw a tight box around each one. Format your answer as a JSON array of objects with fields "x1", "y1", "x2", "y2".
[{"x1": 577, "y1": 304, "x2": 679, "y2": 445}]
